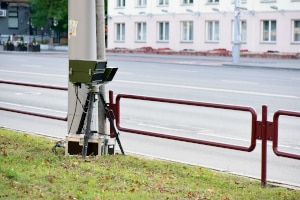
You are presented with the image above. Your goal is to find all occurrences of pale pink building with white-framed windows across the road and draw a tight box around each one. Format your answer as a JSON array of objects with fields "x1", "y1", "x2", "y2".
[{"x1": 107, "y1": 0, "x2": 300, "y2": 53}]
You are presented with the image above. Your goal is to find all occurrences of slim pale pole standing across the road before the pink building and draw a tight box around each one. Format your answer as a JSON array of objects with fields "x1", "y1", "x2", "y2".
[{"x1": 232, "y1": 0, "x2": 241, "y2": 64}]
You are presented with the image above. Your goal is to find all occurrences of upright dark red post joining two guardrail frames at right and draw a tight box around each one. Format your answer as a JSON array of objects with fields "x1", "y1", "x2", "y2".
[{"x1": 261, "y1": 105, "x2": 268, "y2": 186}]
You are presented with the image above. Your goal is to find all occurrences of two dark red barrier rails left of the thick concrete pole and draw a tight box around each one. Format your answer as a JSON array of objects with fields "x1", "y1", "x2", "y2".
[{"x1": 0, "y1": 80, "x2": 68, "y2": 121}]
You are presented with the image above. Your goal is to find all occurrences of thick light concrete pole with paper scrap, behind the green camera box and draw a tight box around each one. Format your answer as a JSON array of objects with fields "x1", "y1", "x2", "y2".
[{"x1": 68, "y1": 0, "x2": 97, "y2": 134}]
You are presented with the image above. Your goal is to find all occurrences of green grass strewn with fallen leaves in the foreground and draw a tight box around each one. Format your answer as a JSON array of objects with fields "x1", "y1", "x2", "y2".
[{"x1": 0, "y1": 128, "x2": 300, "y2": 200}]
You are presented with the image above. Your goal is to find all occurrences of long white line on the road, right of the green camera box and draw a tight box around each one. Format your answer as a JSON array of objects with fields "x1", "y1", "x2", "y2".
[{"x1": 115, "y1": 80, "x2": 300, "y2": 99}]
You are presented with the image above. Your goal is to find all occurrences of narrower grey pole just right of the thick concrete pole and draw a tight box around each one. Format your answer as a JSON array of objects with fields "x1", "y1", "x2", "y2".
[{"x1": 96, "y1": 0, "x2": 107, "y2": 134}]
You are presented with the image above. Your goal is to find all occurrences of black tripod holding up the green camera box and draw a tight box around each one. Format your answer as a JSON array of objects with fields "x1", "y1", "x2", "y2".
[{"x1": 77, "y1": 86, "x2": 125, "y2": 159}]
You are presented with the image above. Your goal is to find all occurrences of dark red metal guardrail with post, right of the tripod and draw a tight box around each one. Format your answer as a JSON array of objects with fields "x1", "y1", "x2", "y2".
[{"x1": 109, "y1": 91, "x2": 300, "y2": 186}]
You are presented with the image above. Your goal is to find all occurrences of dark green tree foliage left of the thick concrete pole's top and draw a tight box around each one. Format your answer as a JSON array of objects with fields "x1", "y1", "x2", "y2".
[{"x1": 29, "y1": 0, "x2": 68, "y2": 31}]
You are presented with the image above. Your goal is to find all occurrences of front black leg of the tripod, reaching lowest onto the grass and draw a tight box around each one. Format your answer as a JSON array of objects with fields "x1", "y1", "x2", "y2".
[{"x1": 82, "y1": 92, "x2": 95, "y2": 159}]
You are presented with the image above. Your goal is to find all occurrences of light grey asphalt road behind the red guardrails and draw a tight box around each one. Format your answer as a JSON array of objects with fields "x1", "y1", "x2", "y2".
[{"x1": 0, "y1": 53, "x2": 300, "y2": 186}]
